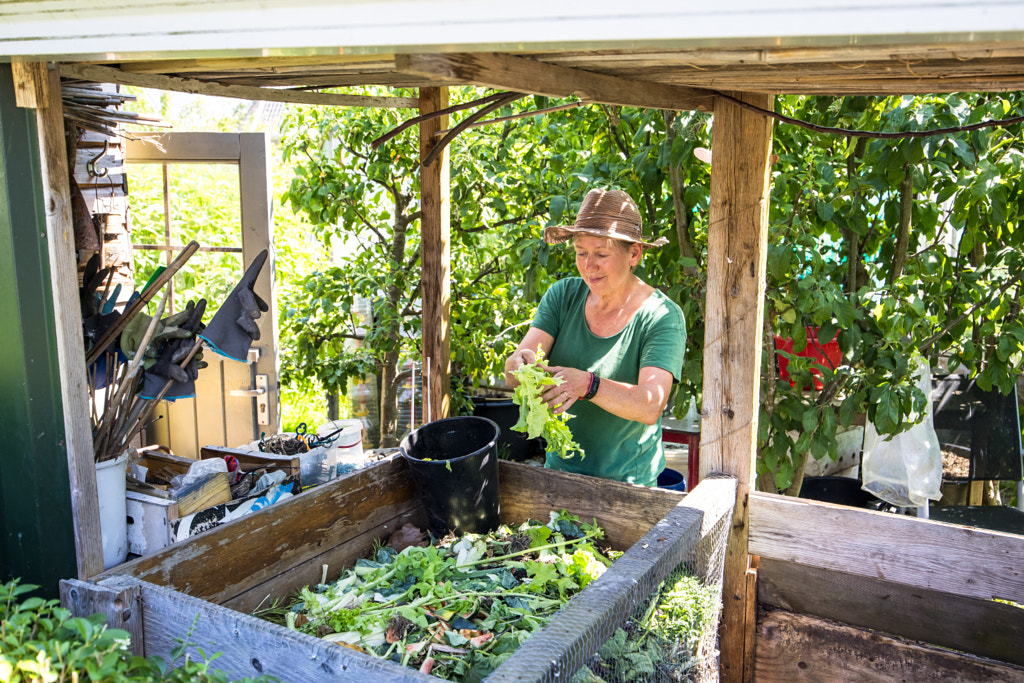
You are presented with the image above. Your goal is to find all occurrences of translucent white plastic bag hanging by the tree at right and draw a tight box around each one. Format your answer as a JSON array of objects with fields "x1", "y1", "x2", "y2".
[{"x1": 861, "y1": 359, "x2": 942, "y2": 508}]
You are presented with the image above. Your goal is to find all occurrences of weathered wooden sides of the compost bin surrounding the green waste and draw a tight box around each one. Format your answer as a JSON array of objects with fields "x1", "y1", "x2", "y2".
[{"x1": 60, "y1": 458, "x2": 736, "y2": 683}]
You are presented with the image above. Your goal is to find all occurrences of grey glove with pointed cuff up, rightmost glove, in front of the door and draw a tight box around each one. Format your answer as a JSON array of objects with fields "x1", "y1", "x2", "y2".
[{"x1": 200, "y1": 249, "x2": 269, "y2": 361}]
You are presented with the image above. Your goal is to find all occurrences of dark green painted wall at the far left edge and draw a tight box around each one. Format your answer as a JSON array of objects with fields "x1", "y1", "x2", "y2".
[{"x1": 0, "y1": 65, "x2": 78, "y2": 597}]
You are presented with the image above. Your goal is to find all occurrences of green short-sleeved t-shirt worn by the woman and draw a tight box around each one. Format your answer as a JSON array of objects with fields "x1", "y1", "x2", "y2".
[{"x1": 532, "y1": 278, "x2": 686, "y2": 486}]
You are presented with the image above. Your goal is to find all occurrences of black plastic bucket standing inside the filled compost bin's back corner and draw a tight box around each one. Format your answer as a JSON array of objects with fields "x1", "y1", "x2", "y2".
[{"x1": 399, "y1": 416, "x2": 501, "y2": 537}]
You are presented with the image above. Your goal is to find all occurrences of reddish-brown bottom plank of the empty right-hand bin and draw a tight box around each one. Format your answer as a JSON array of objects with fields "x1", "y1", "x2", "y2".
[{"x1": 755, "y1": 609, "x2": 1024, "y2": 683}]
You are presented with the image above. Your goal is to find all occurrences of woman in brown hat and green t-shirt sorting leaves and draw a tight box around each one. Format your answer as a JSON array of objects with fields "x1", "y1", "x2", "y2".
[{"x1": 505, "y1": 189, "x2": 686, "y2": 486}]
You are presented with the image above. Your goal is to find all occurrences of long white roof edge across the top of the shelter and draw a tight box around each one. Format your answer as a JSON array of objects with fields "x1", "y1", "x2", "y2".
[{"x1": 0, "y1": 0, "x2": 1024, "y2": 60}]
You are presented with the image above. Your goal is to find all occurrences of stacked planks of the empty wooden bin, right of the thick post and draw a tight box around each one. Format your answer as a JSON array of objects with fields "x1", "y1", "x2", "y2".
[{"x1": 750, "y1": 494, "x2": 1024, "y2": 683}]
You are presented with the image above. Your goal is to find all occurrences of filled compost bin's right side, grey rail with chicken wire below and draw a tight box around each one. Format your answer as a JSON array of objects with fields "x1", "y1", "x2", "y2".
[{"x1": 486, "y1": 476, "x2": 736, "y2": 683}]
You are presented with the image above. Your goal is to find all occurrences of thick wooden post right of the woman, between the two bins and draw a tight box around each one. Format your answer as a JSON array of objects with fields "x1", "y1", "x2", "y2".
[{"x1": 700, "y1": 94, "x2": 772, "y2": 683}]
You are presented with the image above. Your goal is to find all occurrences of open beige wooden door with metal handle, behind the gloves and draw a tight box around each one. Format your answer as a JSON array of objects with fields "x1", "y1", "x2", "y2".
[{"x1": 126, "y1": 133, "x2": 281, "y2": 458}]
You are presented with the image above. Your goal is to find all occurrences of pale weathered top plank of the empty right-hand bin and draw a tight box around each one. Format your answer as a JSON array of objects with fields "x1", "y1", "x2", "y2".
[{"x1": 750, "y1": 493, "x2": 1024, "y2": 603}]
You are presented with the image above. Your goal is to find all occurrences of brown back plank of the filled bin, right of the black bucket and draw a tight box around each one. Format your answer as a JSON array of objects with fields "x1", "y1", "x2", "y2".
[{"x1": 499, "y1": 461, "x2": 680, "y2": 550}]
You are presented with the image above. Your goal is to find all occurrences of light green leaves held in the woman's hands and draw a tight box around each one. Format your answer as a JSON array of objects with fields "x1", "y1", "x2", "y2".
[{"x1": 512, "y1": 349, "x2": 585, "y2": 460}]
